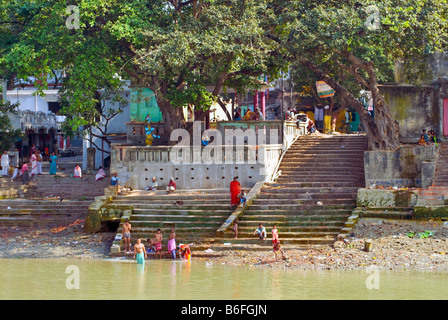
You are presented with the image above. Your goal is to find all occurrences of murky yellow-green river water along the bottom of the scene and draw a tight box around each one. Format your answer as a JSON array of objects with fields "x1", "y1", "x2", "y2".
[{"x1": 0, "y1": 259, "x2": 448, "y2": 300}]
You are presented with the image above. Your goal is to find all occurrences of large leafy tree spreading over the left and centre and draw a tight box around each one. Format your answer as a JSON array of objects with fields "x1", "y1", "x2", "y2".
[{"x1": 0, "y1": 0, "x2": 283, "y2": 138}]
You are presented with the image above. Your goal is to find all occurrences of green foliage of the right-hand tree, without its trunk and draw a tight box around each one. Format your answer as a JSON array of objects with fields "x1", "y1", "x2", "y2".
[{"x1": 266, "y1": 0, "x2": 448, "y2": 95}]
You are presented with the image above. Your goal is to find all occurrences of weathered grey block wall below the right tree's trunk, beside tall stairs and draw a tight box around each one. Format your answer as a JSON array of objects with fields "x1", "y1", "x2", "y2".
[{"x1": 364, "y1": 145, "x2": 437, "y2": 188}]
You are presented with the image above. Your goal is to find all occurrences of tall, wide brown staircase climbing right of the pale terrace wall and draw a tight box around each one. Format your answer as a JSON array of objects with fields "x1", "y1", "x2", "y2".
[{"x1": 216, "y1": 135, "x2": 367, "y2": 246}]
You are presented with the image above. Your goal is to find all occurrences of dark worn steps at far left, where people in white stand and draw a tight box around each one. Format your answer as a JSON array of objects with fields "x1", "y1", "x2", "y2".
[{"x1": 0, "y1": 173, "x2": 108, "y2": 227}]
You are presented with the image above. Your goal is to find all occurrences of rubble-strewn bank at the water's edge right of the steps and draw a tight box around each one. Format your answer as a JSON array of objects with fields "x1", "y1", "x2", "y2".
[{"x1": 206, "y1": 220, "x2": 448, "y2": 272}]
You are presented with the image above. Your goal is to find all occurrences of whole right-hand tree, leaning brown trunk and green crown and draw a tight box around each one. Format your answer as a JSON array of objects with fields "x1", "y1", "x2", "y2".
[{"x1": 266, "y1": 0, "x2": 448, "y2": 150}]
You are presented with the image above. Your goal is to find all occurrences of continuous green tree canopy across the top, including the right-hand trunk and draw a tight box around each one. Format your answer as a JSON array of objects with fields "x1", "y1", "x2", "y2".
[{"x1": 0, "y1": 0, "x2": 448, "y2": 149}]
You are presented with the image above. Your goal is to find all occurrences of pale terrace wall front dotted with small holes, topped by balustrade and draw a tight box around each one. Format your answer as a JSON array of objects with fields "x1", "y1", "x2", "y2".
[{"x1": 110, "y1": 145, "x2": 282, "y2": 190}]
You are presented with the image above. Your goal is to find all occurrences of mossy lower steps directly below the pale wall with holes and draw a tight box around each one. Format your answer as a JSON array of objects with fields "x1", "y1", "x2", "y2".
[{"x1": 111, "y1": 189, "x2": 236, "y2": 251}]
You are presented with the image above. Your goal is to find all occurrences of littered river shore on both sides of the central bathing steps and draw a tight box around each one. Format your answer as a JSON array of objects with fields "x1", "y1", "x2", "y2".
[{"x1": 0, "y1": 220, "x2": 448, "y2": 272}]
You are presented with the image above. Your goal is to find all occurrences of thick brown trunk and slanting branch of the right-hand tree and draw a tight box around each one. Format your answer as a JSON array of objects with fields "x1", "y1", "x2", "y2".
[{"x1": 300, "y1": 60, "x2": 400, "y2": 150}]
